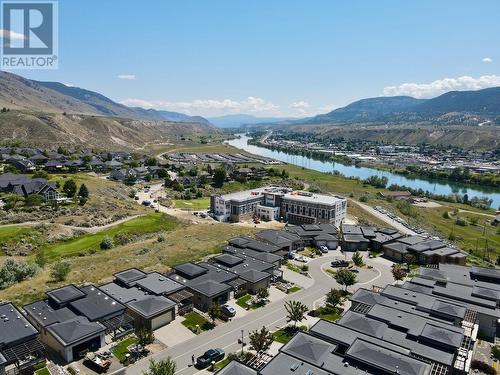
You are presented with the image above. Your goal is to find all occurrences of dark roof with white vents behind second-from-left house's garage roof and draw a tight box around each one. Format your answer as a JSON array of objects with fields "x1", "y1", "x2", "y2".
[{"x1": 70, "y1": 285, "x2": 125, "y2": 321}]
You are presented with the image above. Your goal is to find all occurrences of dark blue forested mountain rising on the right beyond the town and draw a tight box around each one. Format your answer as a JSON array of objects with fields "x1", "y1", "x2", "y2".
[{"x1": 294, "y1": 87, "x2": 500, "y2": 125}]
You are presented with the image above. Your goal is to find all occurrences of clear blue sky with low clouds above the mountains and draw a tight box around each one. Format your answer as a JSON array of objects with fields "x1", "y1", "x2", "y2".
[{"x1": 6, "y1": 0, "x2": 500, "y2": 117}]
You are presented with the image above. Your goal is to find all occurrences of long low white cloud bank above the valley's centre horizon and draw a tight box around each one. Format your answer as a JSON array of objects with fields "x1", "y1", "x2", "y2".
[{"x1": 120, "y1": 96, "x2": 279, "y2": 115}]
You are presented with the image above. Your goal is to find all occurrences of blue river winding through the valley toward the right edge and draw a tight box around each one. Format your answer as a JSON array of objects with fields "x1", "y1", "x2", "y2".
[{"x1": 227, "y1": 134, "x2": 500, "y2": 209}]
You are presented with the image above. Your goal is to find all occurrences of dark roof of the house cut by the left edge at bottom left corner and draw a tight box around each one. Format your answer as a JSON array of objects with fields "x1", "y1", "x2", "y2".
[{"x1": 0, "y1": 303, "x2": 38, "y2": 350}]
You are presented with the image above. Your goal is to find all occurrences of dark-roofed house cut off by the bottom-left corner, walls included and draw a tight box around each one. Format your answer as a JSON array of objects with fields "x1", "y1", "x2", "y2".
[{"x1": 0, "y1": 303, "x2": 45, "y2": 375}]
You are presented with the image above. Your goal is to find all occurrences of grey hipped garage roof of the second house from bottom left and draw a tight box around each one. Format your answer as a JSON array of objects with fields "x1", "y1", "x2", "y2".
[{"x1": 47, "y1": 316, "x2": 105, "y2": 346}]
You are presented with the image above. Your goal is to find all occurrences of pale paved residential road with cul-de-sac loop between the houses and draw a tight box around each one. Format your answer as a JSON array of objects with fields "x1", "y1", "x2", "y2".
[{"x1": 117, "y1": 251, "x2": 393, "y2": 375}]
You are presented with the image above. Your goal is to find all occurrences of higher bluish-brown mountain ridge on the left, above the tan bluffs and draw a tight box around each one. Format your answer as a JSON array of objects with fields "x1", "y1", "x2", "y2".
[{"x1": 0, "y1": 72, "x2": 210, "y2": 125}]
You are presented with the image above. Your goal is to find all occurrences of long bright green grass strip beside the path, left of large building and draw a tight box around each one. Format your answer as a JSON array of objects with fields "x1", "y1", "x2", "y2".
[{"x1": 40, "y1": 213, "x2": 177, "y2": 260}]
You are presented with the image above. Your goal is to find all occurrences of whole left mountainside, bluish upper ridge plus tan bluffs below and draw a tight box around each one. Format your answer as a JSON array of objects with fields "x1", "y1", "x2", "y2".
[{"x1": 0, "y1": 72, "x2": 220, "y2": 150}]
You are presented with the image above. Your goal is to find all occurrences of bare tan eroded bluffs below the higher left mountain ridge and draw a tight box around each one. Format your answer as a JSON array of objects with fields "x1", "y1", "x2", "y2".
[{"x1": 0, "y1": 110, "x2": 215, "y2": 150}]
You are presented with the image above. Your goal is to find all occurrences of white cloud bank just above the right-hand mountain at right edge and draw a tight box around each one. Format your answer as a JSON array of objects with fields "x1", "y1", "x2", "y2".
[{"x1": 384, "y1": 75, "x2": 500, "y2": 98}]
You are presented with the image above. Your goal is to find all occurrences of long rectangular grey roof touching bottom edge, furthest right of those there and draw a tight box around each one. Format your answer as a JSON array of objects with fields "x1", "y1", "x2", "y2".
[{"x1": 346, "y1": 339, "x2": 431, "y2": 375}]
